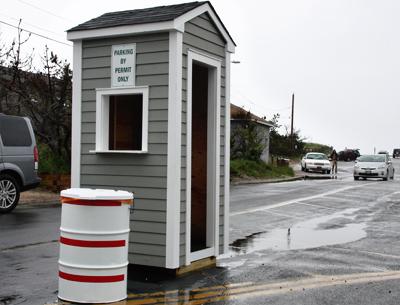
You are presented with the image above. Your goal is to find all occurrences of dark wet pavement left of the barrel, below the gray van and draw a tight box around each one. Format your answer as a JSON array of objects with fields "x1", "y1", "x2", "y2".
[{"x1": 0, "y1": 207, "x2": 60, "y2": 305}]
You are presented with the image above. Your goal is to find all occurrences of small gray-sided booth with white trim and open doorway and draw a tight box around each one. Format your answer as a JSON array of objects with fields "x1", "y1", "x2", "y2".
[{"x1": 67, "y1": 2, "x2": 235, "y2": 270}]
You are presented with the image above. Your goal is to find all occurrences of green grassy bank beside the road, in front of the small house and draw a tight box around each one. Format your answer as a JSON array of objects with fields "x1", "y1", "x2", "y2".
[{"x1": 231, "y1": 159, "x2": 294, "y2": 179}]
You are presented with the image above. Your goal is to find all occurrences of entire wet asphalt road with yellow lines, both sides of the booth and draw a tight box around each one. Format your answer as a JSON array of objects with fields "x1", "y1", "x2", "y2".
[{"x1": 0, "y1": 160, "x2": 400, "y2": 305}]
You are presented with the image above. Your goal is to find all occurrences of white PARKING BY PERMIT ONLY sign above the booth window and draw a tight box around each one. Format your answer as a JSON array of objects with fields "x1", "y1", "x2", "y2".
[{"x1": 111, "y1": 43, "x2": 136, "y2": 87}]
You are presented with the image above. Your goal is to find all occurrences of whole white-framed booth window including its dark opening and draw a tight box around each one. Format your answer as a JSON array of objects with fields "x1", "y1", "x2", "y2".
[{"x1": 94, "y1": 86, "x2": 149, "y2": 153}]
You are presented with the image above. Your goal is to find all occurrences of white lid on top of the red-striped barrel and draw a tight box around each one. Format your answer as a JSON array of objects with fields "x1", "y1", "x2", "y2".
[{"x1": 61, "y1": 188, "x2": 133, "y2": 200}]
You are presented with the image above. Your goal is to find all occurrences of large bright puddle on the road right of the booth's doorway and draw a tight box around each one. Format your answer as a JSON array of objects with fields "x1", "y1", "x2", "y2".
[{"x1": 230, "y1": 209, "x2": 367, "y2": 256}]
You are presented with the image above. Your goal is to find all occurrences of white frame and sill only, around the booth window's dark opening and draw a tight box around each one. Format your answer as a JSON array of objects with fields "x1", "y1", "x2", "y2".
[{"x1": 90, "y1": 86, "x2": 149, "y2": 154}]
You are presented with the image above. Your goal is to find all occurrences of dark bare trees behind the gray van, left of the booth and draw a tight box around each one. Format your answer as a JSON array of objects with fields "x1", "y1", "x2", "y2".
[{"x1": 0, "y1": 20, "x2": 72, "y2": 169}]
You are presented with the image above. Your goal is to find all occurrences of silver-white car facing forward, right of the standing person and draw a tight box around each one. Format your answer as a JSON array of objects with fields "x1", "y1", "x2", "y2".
[{"x1": 354, "y1": 154, "x2": 394, "y2": 181}]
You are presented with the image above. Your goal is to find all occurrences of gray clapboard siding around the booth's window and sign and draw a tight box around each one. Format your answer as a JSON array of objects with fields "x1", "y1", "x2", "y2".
[{"x1": 81, "y1": 33, "x2": 169, "y2": 267}]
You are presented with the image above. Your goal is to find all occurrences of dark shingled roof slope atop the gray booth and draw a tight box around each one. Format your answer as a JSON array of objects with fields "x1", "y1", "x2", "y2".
[{"x1": 67, "y1": 1, "x2": 206, "y2": 32}]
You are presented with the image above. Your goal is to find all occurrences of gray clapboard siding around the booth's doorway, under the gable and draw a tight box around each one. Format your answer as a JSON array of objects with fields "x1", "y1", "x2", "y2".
[{"x1": 180, "y1": 13, "x2": 226, "y2": 265}]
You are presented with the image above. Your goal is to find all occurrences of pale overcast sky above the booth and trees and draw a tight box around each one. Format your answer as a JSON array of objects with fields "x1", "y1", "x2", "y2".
[{"x1": 0, "y1": 0, "x2": 400, "y2": 153}]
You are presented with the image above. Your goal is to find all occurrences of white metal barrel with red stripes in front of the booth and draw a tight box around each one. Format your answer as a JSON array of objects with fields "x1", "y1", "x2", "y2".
[{"x1": 58, "y1": 188, "x2": 133, "y2": 303}]
